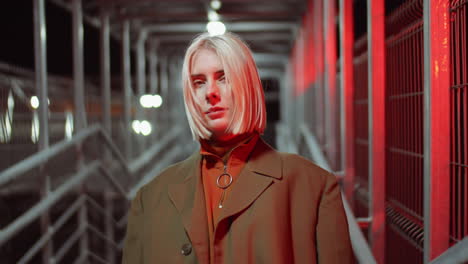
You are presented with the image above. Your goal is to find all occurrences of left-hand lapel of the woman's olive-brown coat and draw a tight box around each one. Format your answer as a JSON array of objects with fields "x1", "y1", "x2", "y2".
[{"x1": 168, "y1": 153, "x2": 210, "y2": 263}]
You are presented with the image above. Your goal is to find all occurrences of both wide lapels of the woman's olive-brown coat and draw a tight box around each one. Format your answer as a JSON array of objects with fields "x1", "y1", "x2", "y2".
[{"x1": 168, "y1": 138, "x2": 282, "y2": 263}]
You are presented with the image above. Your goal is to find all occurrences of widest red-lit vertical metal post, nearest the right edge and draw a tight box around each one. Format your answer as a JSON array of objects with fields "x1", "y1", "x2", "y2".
[{"x1": 423, "y1": 0, "x2": 450, "y2": 263}]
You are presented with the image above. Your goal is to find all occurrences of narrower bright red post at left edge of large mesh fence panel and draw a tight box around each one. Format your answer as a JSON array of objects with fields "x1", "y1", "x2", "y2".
[{"x1": 367, "y1": 0, "x2": 385, "y2": 263}]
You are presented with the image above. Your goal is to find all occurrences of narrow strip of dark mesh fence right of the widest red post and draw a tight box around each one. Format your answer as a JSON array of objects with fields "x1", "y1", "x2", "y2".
[{"x1": 450, "y1": 0, "x2": 468, "y2": 244}]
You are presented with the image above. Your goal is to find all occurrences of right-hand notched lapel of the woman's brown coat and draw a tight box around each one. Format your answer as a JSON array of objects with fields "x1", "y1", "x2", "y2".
[{"x1": 215, "y1": 138, "x2": 282, "y2": 228}]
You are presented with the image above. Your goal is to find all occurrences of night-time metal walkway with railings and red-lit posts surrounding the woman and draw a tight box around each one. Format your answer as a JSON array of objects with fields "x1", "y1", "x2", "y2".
[{"x1": 0, "y1": 0, "x2": 468, "y2": 264}]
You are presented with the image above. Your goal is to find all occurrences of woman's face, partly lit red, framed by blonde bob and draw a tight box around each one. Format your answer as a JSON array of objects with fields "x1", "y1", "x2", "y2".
[{"x1": 191, "y1": 49, "x2": 234, "y2": 141}]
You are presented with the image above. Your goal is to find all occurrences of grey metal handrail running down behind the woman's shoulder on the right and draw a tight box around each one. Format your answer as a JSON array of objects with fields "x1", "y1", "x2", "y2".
[{"x1": 299, "y1": 124, "x2": 377, "y2": 264}]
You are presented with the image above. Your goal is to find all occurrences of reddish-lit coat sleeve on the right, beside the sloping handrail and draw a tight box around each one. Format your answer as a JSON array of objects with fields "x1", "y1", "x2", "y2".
[{"x1": 316, "y1": 173, "x2": 354, "y2": 264}]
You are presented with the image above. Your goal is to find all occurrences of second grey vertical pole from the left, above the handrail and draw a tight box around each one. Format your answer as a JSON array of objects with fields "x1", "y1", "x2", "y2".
[{"x1": 72, "y1": 0, "x2": 87, "y2": 132}]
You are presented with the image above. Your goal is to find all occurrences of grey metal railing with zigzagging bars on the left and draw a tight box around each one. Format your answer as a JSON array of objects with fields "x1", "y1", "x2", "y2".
[{"x1": 0, "y1": 125, "x2": 186, "y2": 263}]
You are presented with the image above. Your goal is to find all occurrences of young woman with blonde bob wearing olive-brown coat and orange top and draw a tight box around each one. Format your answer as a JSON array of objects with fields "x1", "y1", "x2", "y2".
[{"x1": 123, "y1": 33, "x2": 353, "y2": 264}]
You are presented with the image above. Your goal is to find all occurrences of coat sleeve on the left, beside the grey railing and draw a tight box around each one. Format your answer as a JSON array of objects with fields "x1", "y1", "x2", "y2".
[{"x1": 122, "y1": 189, "x2": 143, "y2": 264}]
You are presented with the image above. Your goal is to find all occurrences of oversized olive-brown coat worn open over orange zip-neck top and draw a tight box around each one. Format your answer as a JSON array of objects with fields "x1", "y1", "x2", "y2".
[{"x1": 123, "y1": 139, "x2": 353, "y2": 264}]
